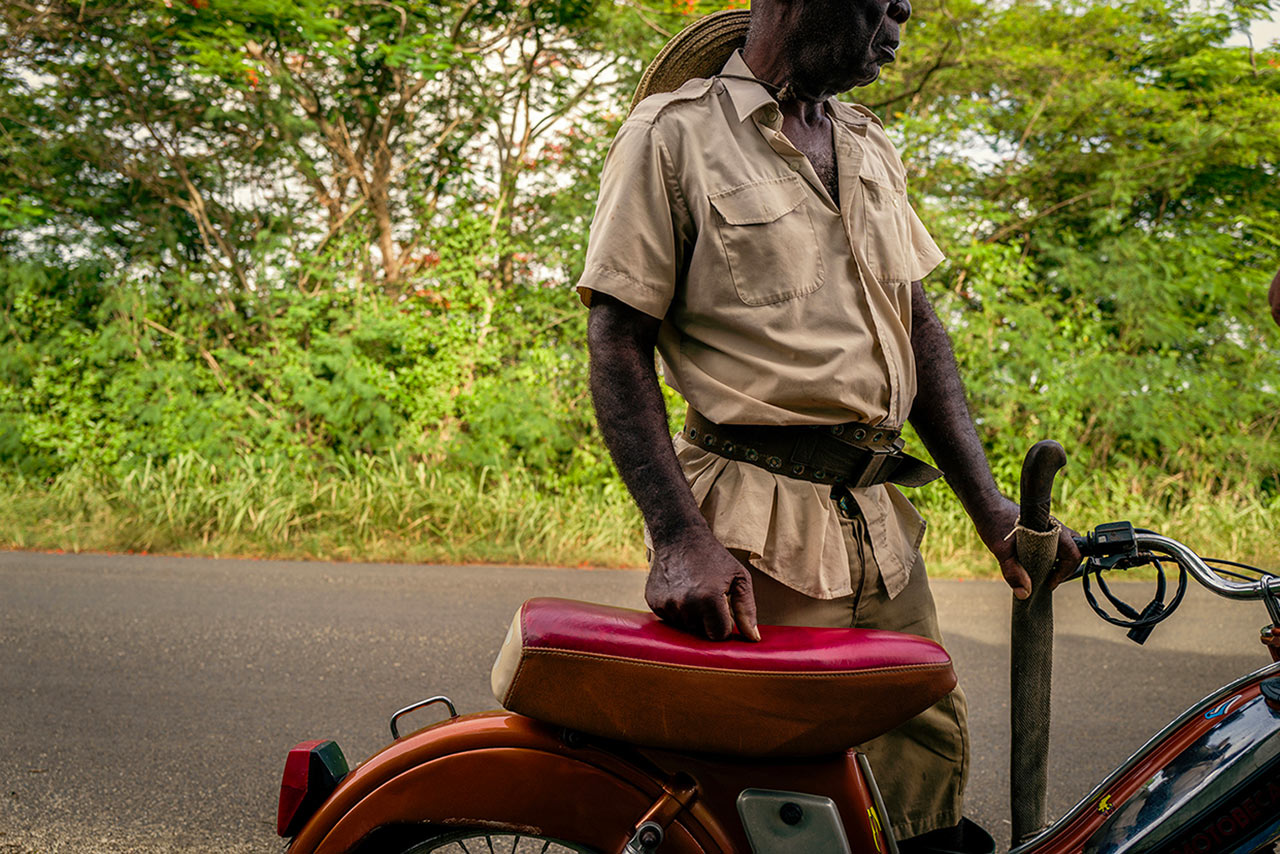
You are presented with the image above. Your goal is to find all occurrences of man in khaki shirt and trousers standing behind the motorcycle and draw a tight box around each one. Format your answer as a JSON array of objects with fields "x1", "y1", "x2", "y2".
[{"x1": 577, "y1": 0, "x2": 1079, "y2": 850}]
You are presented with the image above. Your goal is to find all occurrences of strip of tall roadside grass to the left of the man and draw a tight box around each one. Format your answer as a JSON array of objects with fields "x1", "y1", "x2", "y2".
[{"x1": 0, "y1": 455, "x2": 644, "y2": 566}]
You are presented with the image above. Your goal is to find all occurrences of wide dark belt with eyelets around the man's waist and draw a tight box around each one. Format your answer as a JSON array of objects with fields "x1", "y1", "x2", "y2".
[{"x1": 685, "y1": 407, "x2": 942, "y2": 489}]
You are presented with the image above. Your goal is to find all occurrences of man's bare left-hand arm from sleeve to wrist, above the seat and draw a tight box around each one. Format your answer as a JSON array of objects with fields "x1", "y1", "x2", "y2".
[{"x1": 588, "y1": 296, "x2": 707, "y2": 547}]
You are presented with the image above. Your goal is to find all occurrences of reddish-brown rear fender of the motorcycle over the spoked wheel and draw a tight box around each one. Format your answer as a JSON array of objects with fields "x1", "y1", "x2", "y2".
[{"x1": 289, "y1": 712, "x2": 724, "y2": 854}]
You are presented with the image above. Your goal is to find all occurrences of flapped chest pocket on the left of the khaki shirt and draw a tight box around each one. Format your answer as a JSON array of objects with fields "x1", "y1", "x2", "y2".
[{"x1": 708, "y1": 175, "x2": 826, "y2": 306}]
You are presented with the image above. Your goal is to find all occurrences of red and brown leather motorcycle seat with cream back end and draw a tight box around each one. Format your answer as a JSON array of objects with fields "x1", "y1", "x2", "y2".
[{"x1": 493, "y1": 599, "x2": 956, "y2": 758}]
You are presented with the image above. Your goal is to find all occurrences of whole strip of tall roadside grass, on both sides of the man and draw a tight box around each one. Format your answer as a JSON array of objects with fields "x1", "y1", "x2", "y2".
[{"x1": 0, "y1": 455, "x2": 1280, "y2": 577}]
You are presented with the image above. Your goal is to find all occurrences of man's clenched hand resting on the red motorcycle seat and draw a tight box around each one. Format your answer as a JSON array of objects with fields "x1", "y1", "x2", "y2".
[{"x1": 644, "y1": 531, "x2": 760, "y2": 640}]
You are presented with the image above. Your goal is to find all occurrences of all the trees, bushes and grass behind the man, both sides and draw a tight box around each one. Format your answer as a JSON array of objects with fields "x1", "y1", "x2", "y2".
[{"x1": 0, "y1": 0, "x2": 1280, "y2": 573}]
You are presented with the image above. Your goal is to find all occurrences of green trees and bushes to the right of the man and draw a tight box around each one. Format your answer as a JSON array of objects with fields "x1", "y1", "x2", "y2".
[{"x1": 880, "y1": 0, "x2": 1280, "y2": 490}]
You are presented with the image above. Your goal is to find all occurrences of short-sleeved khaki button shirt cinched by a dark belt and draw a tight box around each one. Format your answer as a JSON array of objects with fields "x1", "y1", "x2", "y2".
[{"x1": 577, "y1": 54, "x2": 942, "y2": 599}]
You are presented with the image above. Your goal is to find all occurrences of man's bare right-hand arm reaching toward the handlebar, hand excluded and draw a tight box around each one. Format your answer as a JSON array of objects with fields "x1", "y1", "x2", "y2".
[{"x1": 910, "y1": 282, "x2": 1004, "y2": 529}]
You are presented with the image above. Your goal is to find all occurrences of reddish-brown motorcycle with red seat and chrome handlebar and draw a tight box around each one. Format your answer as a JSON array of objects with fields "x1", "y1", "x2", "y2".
[{"x1": 278, "y1": 443, "x2": 1280, "y2": 854}]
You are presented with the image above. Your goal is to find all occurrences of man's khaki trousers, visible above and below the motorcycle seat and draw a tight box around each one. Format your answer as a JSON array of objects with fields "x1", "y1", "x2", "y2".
[{"x1": 737, "y1": 502, "x2": 969, "y2": 839}]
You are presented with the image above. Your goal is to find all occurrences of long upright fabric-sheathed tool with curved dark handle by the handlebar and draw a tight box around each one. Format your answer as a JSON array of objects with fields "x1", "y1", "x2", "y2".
[{"x1": 1009, "y1": 442, "x2": 1066, "y2": 846}]
